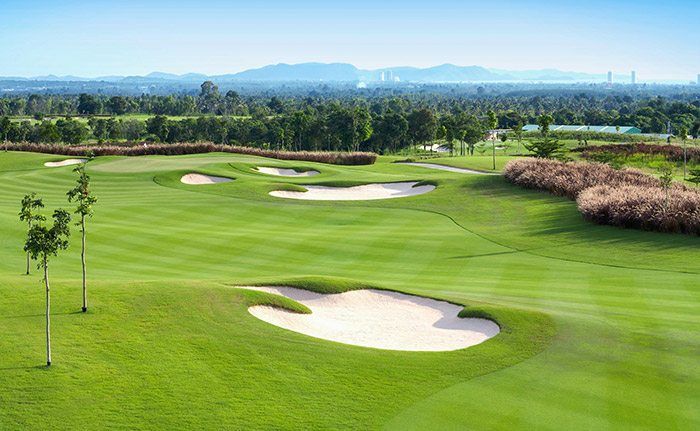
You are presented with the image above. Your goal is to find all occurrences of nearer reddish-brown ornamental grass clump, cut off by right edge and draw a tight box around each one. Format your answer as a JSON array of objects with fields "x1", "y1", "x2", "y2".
[{"x1": 576, "y1": 185, "x2": 700, "y2": 235}]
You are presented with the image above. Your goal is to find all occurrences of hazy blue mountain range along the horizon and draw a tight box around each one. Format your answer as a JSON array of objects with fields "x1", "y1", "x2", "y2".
[{"x1": 0, "y1": 63, "x2": 629, "y2": 84}]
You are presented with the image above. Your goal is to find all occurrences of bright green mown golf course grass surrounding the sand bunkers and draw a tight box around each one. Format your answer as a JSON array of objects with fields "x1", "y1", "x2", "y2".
[{"x1": 0, "y1": 153, "x2": 700, "y2": 430}]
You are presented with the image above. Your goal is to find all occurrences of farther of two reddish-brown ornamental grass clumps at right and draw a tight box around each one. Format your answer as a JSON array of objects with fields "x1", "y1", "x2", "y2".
[{"x1": 503, "y1": 159, "x2": 660, "y2": 199}]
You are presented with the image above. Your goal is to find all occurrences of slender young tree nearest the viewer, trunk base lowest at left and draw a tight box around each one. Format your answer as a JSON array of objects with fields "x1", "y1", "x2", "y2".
[{"x1": 24, "y1": 209, "x2": 70, "y2": 366}]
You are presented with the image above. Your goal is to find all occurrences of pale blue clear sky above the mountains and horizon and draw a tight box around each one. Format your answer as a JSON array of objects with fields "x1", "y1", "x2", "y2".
[{"x1": 0, "y1": 0, "x2": 700, "y2": 79}]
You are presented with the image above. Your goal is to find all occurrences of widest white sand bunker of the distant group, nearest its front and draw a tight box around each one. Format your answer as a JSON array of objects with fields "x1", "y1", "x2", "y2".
[{"x1": 270, "y1": 181, "x2": 435, "y2": 201}]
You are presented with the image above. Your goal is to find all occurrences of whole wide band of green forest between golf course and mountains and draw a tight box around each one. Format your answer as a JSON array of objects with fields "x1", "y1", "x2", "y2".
[{"x1": 0, "y1": 81, "x2": 700, "y2": 153}]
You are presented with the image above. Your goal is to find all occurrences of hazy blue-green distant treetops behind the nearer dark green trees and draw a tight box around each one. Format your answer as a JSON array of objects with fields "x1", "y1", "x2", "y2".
[{"x1": 0, "y1": 81, "x2": 700, "y2": 133}]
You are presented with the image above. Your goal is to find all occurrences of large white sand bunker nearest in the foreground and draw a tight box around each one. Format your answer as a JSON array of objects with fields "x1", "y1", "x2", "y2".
[{"x1": 241, "y1": 286, "x2": 500, "y2": 352}]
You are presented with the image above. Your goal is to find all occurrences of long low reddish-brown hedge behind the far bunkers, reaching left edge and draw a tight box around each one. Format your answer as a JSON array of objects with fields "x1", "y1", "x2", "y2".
[{"x1": 7, "y1": 143, "x2": 377, "y2": 165}]
